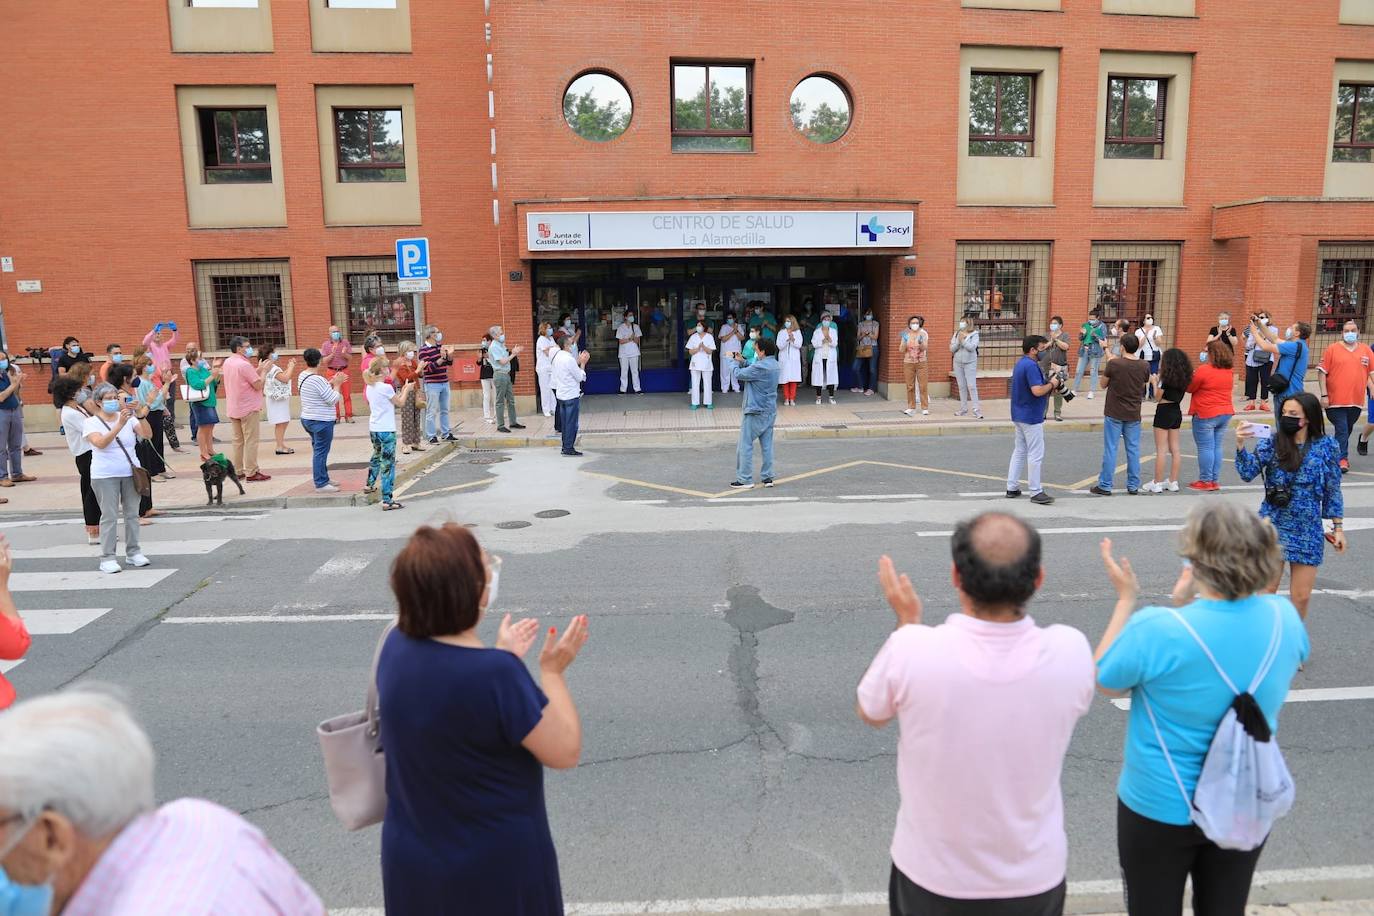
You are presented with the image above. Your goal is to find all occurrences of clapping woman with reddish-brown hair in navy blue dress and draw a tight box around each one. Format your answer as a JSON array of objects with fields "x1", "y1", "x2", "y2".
[{"x1": 376, "y1": 521, "x2": 588, "y2": 916}]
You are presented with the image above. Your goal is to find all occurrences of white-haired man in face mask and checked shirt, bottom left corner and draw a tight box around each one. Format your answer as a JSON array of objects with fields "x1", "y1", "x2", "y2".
[{"x1": 0, "y1": 687, "x2": 324, "y2": 916}]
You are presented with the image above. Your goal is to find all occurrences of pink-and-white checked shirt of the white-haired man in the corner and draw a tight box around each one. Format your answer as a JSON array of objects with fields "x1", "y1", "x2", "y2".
[{"x1": 62, "y1": 798, "x2": 324, "y2": 916}]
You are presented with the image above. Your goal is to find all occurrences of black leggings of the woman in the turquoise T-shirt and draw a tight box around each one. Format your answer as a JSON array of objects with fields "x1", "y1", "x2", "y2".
[{"x1": 1117, "y1": 799, "x2": 1267, "y2": 916}]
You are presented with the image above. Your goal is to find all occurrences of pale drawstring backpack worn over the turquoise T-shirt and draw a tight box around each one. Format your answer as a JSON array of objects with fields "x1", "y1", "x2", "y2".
[{"x1": 1140, "y1": 606, "x2": 1294, "y2": 850}]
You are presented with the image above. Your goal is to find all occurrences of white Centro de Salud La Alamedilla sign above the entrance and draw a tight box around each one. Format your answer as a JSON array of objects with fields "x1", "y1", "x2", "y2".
[{"x1": 525, "y1": 210, "x2": 916, "y2": 251}]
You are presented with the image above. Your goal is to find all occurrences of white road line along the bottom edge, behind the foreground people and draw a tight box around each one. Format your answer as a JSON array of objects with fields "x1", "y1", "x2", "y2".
[{"x1": 330, "y1": 865, "x2": 1374, "y2": 916}]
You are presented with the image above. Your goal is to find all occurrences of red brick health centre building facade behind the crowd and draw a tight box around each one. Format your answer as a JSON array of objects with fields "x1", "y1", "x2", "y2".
[{"x1": 0, "y1": 0, "x2": 1374, "y2": 397}]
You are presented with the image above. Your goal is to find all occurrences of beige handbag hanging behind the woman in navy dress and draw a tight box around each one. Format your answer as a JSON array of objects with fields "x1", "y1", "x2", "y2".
[{"x1": 315, "y1": 623, "x2": 396, "y2": 829}]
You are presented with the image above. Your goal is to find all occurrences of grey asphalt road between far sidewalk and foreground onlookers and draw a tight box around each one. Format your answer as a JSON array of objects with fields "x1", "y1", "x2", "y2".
[{"x1": 0, "y1": 434, "x2": 1374, "y2": 913}]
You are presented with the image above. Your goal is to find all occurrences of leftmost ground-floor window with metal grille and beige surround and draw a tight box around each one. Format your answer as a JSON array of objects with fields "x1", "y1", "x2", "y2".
[{"x1": 194, "y1": 261, "x2": 295, "y2": 350}]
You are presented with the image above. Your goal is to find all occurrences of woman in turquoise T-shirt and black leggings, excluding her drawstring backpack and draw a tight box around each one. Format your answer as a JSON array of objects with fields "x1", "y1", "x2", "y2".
[{"x1": 1096, "y1": 503, "x2": 1309, "y2": 916}]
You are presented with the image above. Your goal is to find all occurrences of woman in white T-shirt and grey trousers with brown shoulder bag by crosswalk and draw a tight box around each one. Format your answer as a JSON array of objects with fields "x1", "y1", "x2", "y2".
[{"x1": 82, "y1": 382, "x2": 153, "y2": 573}]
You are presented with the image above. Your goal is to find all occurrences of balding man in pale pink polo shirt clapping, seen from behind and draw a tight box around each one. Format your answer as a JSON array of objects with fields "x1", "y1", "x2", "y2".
[{"x1": 859, "y1": 512, "x2": 1095, "y2": 916}]
